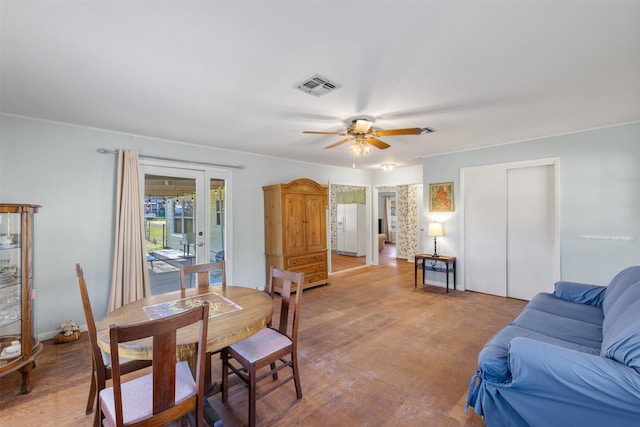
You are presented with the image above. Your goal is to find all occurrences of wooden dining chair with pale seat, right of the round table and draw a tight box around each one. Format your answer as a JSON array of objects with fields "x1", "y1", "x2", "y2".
[{"x1": 221, "y1": 267, "x2": 304, "y2": 426}]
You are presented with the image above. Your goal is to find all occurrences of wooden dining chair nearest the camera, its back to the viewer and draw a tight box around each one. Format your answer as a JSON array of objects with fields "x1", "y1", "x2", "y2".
[{"x1": 100, "y1": 301, "x2": 209, "y2": 427}]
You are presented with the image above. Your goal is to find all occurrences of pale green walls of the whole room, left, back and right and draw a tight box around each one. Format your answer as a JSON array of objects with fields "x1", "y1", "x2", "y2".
[{"x1": 0, "y1": 116, "x2": 640, "y2": 338}]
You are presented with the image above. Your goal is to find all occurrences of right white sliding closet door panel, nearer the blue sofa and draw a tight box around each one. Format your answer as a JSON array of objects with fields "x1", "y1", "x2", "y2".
[{"x1": 507, "y1": 165, "x2": 555, "y2": 300}]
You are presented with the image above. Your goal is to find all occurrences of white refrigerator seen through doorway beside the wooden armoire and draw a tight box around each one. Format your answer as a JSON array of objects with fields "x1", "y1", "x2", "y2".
[{"x1": 336, "y1": 203, "x2": 367, "y2": 256}]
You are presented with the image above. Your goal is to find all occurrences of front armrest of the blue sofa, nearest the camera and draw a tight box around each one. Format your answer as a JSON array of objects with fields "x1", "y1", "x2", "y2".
[{"x1": 508, "y1": 337, "x2": 640, "y2": 426}]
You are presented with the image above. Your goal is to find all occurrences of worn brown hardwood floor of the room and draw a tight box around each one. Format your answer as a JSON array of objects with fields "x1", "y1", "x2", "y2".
[{"x1": 0, "y1": 258, "x2": 525, "y2": 427}]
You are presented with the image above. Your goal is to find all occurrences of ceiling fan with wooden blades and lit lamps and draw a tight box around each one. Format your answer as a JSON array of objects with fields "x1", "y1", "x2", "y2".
[{"x1": 302, "y1": 119, "x2": 433, "y2": 156}]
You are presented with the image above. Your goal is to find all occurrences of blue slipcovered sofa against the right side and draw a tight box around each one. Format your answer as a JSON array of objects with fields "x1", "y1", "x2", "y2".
[{"x1": 467, "y1": 266, "x2": 640, "y2": 427}]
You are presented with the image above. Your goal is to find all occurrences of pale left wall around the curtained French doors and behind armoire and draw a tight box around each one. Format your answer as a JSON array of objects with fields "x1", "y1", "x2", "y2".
[{"x1": 0, "y1": 116, "x2": 371, "y2": 339}]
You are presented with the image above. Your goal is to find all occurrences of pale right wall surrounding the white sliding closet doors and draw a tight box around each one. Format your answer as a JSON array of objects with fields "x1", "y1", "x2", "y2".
[{"x1": 423, "y1": 123, "x2": 640, "y2": 290}]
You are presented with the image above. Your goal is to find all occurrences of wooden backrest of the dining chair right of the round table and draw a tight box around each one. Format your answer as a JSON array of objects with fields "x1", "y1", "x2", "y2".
[{"x1": 265, "y1": 266, "x2": 304, "y2": 346}]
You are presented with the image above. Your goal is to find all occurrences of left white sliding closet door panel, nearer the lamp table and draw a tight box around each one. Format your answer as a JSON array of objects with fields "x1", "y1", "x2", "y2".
[{"x1": 462, "y1": 168, "x2": 507, "y2": 296}]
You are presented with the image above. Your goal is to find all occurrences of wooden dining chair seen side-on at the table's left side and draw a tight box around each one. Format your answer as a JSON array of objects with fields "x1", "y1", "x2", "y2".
[{"x1": 76, "y1": 264, "x2": 151, "y2": 427}]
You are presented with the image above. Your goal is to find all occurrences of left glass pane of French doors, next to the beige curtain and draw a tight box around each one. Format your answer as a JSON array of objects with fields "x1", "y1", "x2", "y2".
[{"x1": 143, "y1": 174, "x2": 196, "y2": 295}]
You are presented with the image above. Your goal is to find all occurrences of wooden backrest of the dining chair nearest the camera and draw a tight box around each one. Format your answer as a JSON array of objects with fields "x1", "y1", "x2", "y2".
[{"x1": 109, "y1": 301, "x2": 209, "y2": 425}]
